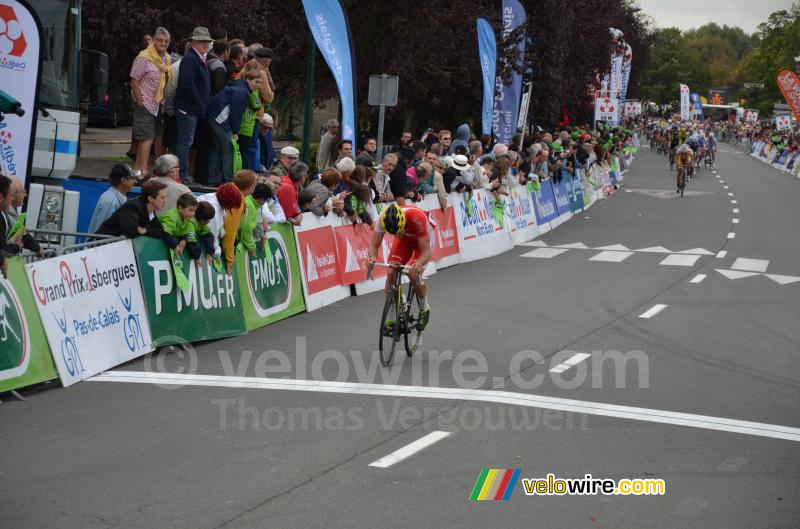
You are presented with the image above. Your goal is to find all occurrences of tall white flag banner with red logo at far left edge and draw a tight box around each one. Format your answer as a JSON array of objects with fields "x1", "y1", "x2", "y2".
[{"x1": 0, "y1": 0, "x2": 42, "y2": 182}]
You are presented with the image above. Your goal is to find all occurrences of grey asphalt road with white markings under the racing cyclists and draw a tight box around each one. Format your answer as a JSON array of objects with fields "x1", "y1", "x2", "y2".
[{"x1": 0, "y1": 145, "x2": 800, "y2": 529}]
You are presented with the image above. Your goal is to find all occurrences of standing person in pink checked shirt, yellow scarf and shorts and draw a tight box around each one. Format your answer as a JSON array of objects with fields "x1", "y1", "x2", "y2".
[{"x1": 131, "y1": 28, "x2": 173, "y2": 177}]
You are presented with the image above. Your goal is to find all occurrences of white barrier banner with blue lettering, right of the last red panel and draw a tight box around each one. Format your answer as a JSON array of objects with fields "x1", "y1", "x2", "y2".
[{"x1": 450, "y1": 189, "x2": 514, "y2": 263}]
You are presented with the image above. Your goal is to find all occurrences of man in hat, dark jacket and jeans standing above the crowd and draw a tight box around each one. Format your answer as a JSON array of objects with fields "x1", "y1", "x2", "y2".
[{"x1": 172, "y1": 27, "x2": 214, "y2": 186}]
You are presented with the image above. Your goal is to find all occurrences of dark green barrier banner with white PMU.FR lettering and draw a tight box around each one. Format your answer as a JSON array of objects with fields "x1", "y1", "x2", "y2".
[{"x1": 133, "y1": 237, "x2": 247, "y2": 346}]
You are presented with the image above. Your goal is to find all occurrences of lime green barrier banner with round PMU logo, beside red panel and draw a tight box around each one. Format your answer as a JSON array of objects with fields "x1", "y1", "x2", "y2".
[{"x1": 236, "y1": 224, "x2": 306, "y2": 331}]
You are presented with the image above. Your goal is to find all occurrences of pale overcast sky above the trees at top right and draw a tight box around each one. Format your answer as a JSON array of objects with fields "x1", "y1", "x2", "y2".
[{"x1": 639, "y1": 0, "x2": 794, "y2": 33}]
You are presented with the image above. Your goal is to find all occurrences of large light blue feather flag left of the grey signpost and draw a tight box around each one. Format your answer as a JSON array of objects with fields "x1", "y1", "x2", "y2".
[{"x1": 303, "y1": 0, "x2": 356, "y2": 141}]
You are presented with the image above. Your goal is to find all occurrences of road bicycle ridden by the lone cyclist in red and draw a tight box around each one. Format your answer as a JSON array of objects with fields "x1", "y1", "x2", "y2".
[{"x1": 370, "y1": 263, "x2": 422, "y2": 367}]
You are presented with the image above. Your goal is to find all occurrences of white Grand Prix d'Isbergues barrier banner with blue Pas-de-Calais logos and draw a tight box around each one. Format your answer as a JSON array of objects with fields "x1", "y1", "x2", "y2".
[{"x1": 25, "y1": 241, "x2": 153, "y2": 386}]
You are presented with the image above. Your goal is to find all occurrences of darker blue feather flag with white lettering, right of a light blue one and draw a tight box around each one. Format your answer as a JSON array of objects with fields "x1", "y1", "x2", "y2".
[{"x1": 492, "y1": 0, "x2": 525, "y2": 145}]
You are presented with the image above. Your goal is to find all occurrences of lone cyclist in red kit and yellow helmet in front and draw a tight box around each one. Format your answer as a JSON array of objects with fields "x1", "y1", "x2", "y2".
[{"x1": 367, "y1": 204, "x2": 431, "y2": 330}]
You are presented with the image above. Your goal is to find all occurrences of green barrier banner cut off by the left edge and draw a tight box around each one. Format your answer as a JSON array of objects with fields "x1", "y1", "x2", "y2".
[{"x1": 0, "y1": 257, "x2": 58, "y2": 392}]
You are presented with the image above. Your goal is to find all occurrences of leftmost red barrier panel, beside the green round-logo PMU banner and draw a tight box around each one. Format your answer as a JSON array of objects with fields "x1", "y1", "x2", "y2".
[{"x1": 297, "y1": 226, "x2": 342, "y2": 294}]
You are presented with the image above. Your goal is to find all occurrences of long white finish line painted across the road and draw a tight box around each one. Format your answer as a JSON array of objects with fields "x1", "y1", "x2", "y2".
[{"x1": 88, "y1": 371, "x2": 800, "y2": 442}]
